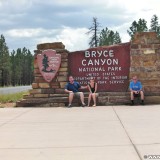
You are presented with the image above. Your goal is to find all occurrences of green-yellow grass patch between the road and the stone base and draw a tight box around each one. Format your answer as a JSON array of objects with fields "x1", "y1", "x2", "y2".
[{"x1": 0, "y1": 92, "x2": 28, "y2": 103}]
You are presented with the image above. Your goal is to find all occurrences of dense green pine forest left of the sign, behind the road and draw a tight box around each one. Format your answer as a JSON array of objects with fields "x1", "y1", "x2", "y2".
[{"x1": 0, "y1": 35, "x2": 33, "y2": 86}]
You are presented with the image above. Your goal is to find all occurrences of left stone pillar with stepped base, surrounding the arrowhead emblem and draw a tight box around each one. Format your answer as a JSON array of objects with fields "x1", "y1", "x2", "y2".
[{"x1": 17, "y1": 42, "x2": 69, "y2": 107}]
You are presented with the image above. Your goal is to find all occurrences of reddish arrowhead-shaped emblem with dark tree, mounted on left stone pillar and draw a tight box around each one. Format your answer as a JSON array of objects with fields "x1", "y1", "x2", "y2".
[{"x1": 37, "y1": 49, "x2": 61, "y2": 82}]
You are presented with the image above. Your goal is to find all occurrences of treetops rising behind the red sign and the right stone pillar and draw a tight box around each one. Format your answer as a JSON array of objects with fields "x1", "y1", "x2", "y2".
[{"x1": 87, "y1": 15, "x2": 160, "y2": 47}]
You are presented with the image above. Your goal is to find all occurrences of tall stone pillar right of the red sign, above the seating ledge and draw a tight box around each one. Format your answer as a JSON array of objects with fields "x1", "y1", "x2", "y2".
[{"x1": 130, "y1": 32, "x2": 160, "y2": 94}]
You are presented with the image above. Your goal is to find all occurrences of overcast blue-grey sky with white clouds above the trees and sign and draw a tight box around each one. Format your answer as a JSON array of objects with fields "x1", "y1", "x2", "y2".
[{"x1": 0, "y1": 0, "x2": 160, "y2": 52}]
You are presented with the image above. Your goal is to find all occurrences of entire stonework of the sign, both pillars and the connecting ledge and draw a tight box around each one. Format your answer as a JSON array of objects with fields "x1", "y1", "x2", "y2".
[{"x1": 17, "y1": 32, "x2": 160, "y2": 107}]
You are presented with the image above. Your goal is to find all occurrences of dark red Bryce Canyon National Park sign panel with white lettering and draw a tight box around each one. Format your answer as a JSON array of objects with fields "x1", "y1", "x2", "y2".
[{"x1": 69, "y1": 43, "x2": 130, "y2": 92}]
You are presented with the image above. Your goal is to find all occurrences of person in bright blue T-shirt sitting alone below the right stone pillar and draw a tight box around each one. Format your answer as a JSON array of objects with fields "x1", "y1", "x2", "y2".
[{"x1": 129, "y1": 76, "x2": 144, "y2": 105}]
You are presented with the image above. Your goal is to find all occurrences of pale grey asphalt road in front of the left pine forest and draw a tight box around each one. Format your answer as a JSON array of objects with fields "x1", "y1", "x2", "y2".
[{"x1": 0, "y1": 86, "x2": 32, "y2": 94}]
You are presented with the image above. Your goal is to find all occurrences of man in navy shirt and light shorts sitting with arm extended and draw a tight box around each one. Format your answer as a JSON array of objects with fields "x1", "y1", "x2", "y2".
[{"x1": 65, "y1": 76, "x2": 87, "y2": 107}]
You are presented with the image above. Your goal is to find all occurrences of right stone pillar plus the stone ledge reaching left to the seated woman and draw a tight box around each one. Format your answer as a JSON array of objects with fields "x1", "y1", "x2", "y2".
[{"x1": 99, "y1": 32, "x2": 160, "y2": 105}]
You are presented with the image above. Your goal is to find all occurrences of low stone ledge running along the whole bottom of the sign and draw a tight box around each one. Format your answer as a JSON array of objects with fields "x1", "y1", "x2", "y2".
[{"x1": 16, "y1": 92, "x2": 160, "y2": 107}]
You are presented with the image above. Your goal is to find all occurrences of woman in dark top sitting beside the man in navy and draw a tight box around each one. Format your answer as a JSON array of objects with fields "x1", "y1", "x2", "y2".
[{"x1": 88, "y1": 78, "x2": 97, "y2": 107}]
